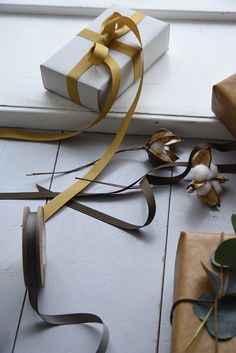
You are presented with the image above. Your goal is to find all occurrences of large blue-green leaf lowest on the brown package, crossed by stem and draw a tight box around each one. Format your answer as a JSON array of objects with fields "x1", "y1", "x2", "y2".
[{"x1": 193, "y1": 293, "x2": 236, "y2": 340}]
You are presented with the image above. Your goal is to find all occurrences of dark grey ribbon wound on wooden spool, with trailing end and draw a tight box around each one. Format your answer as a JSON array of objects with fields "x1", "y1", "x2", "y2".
[{"x1": 22, "y1": 207, "x2": 109, "y2": 353}]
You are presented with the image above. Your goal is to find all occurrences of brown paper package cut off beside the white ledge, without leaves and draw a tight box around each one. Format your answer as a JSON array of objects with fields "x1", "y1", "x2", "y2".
[{"x1": 212, "y1": 74, "x2": 236, "y2": 138}]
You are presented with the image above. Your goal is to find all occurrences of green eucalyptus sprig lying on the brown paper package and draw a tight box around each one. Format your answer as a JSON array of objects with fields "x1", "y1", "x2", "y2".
[{"x1": 193, "y1": 214, "x2": 236, "y2": 340}]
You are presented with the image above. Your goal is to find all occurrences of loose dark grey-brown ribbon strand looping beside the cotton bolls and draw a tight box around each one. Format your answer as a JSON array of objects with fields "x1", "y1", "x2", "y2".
[{"x1": 0, "y1": 142, "x2": 236, "y2": 230}]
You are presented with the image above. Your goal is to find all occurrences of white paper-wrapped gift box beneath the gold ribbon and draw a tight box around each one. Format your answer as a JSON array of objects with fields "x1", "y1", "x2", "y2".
[{"x1": 41, "y1": 5, "x2": 169, "y2": 111}]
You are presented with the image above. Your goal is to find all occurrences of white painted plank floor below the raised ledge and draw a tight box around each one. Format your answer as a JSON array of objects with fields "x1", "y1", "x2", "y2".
[{"x1": 0, "y1": 133, "x2": 236, "y2": 353}]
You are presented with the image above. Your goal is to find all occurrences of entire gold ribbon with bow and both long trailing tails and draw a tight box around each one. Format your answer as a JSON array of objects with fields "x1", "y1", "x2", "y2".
[{"x1": 0, "y1": 12, "x2": 144, "y2": 220}]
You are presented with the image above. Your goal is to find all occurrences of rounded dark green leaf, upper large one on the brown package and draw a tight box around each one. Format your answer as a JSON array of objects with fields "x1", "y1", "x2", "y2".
[{"x1": 215, "y1": 238, "x2": 236, "y2": 270}]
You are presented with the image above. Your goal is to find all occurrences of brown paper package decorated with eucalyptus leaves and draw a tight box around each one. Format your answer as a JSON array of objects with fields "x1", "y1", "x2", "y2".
[{"x1": 171, "y1": 232, "x2": 236, "y2": 353}]
